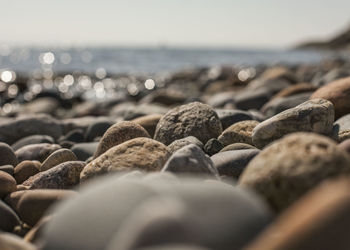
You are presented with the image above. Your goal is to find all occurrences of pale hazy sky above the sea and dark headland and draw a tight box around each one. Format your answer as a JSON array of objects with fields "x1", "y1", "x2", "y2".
[{"x1": 0, "y1": 0, "x2": 350, "y2": 48}]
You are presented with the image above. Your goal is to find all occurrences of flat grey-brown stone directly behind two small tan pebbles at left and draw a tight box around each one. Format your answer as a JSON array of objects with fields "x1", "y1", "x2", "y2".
[{"x1": 15, "y1": 143, "x2": 61, "y2": 162}]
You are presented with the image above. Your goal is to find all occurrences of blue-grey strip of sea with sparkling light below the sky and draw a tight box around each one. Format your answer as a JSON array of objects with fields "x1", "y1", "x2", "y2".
[{"x1": 0, "y1": 45, "x2": 348, "y2": 75}]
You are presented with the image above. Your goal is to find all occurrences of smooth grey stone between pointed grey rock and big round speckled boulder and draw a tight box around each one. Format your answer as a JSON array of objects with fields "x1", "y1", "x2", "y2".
[{"x1": 211, "y1": 149, "x2": 260, "y2": 179}]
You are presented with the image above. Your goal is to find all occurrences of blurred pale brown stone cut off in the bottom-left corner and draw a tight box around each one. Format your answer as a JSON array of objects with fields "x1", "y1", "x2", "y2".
[{"x1": 0, "y1": 233, "x2": 37, "y2": 250}]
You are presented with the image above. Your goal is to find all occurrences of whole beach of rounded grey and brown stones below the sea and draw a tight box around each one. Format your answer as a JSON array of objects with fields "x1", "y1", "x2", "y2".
[{"x1": 0, "y1": 59, "x2": 350, "y2": 250}]
